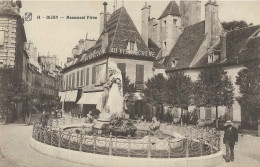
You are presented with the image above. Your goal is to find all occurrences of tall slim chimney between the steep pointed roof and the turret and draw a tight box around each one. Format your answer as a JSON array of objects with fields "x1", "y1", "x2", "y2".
[{"x1": 141, "y1": 2, "x2": 150, "y2": 46}]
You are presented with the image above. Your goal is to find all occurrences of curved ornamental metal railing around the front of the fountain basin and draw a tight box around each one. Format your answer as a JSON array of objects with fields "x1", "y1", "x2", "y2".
[{"x1": 32, "y1": 118, "x2": 220, "y2": 158}]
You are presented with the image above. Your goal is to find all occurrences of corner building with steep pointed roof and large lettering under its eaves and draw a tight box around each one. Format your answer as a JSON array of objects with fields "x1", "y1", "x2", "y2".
[{"x1": 61, "y1": 5, "x2": 155, "y2": 117}]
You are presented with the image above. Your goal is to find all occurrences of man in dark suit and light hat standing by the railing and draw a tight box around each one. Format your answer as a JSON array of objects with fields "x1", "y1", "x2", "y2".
[{"x1": 223, "y1": 120, "x2": 238, "y2": 162}]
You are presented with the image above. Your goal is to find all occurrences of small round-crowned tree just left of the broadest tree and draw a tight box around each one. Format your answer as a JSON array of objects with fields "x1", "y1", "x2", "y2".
[{"x1": 166, "y1": 72, "x2": 193, "y2": 125}]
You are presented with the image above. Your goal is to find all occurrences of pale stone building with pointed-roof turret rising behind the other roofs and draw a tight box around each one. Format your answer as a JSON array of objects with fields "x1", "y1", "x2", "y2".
[{"x1": 141, "y1": 0, "x2": 201, "y2": 58}]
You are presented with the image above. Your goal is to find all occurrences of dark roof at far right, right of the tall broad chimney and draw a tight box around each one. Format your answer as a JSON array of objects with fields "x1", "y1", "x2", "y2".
[{"x1": 194, "y1": 25, "x2": 260, "y2": 67}]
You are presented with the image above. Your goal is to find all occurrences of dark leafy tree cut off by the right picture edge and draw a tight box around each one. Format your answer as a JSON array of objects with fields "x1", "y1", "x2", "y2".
[{"x1": 236, "y1": 61, "x2": 260, "y2": 132}]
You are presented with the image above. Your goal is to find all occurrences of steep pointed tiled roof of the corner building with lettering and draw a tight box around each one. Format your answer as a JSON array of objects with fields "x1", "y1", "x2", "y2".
[{"x1": 63, "y1": 7, "x2": 152, "y2": 72}]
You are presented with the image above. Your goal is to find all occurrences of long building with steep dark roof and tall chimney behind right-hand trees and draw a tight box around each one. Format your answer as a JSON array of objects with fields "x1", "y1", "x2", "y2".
[{"x1": 161, "y1": 1, "x2": 260, "y2": 124}]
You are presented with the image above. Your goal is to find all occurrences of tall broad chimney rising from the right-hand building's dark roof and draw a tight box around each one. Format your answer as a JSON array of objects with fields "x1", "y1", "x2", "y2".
[{"x1": 205, "y1": 0, "x2": 222, "y2": 47}]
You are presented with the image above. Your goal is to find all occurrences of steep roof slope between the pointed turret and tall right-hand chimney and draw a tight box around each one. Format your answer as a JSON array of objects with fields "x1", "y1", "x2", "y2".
[{"x1": 164, "y1": 21, "x2": 206, "y2": 70}]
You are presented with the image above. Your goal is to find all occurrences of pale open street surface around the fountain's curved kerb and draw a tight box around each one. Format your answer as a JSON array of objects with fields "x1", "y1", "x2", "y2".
[{"x1": 0, "y1": 124, "x2": 260, "y2": 167}]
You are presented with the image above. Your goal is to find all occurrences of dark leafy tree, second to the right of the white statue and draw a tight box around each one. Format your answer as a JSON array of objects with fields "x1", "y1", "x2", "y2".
[{"x1": 143, "y1": 74, "x2": 166, "y2": 121}]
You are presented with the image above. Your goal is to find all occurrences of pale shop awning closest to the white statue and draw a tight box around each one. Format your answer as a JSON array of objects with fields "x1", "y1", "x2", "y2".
[{"x1": 78, "y1": 92, "x2": 103, "y2": 104}]
